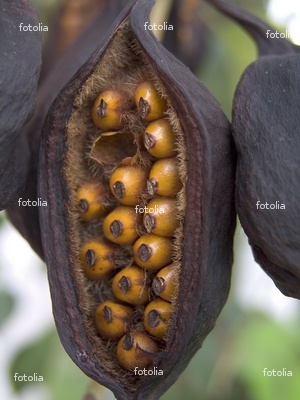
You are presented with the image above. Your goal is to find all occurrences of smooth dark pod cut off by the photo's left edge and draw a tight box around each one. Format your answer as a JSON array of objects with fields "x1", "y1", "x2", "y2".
[{"x1": 0, "y1": 0, "x2": 41, "y2": 210}]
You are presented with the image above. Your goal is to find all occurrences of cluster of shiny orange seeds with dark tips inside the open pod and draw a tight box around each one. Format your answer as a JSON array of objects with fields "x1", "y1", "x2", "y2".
[{"x1": 77, "y1": 80, "x2": 182, "y2": 370}]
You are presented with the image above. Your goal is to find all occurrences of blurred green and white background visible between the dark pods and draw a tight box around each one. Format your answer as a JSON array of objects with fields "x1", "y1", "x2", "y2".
[{"x1": 0, "y1": 0, "x2": 300, "y2": 400}]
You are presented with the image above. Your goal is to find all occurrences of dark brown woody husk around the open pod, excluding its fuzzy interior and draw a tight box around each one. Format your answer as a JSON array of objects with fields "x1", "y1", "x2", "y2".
[{"x1": 38, "y1": 0, "x2": 235, "y2": 399}]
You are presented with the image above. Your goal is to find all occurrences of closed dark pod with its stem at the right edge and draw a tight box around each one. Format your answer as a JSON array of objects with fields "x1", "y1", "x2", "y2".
[{"x1": 210, "y1": 0, "x2": 300, "y2": 299}]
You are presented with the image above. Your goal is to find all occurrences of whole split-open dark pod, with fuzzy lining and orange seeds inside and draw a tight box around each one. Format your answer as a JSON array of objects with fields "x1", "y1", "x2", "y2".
[{"x1": 39, "y1": 0, "x2": 235, "y2": 399}]
